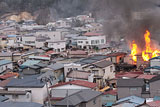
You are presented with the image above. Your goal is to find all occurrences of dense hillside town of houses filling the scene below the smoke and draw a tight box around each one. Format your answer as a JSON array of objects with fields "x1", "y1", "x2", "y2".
[{"x1": 0, "y1": 15, "x2": 160, "y2": 107}]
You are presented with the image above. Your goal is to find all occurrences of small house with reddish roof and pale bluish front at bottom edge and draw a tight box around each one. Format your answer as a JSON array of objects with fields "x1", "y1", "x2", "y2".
[{"x1": 102, "y1": 90, "x2": 117, "y2": 107}]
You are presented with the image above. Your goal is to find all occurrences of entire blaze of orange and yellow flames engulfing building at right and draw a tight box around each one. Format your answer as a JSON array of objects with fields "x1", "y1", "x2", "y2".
[{"x1": 131, "y1": 30, "x2": 160, "y2": 63}]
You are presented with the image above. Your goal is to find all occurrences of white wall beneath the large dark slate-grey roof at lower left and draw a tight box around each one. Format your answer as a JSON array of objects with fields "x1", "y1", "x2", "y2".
[{"x1": 8, "y1": 85, "x2": 47, "y2": 104}]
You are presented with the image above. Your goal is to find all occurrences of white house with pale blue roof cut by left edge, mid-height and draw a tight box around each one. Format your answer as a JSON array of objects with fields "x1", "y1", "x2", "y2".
[{"x1": 0, "y1": 60, "x2": 13, "y2": 73}]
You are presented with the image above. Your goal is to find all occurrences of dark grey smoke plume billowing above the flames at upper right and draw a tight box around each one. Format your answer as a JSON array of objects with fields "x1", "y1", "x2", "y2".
[{"x1": 92, "y1": 0, "x2": 160, "y2": 49}]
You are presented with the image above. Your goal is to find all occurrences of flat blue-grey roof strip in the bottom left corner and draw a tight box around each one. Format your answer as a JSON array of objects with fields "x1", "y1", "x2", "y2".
[{"x1": 0, "y1": 102, "x2": 43, "y2": 107}]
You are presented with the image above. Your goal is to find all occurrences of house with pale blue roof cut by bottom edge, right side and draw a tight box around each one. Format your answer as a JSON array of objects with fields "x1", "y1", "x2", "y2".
[{"x1": 113, "y1": 96, "x2": 145, "y2": 107}]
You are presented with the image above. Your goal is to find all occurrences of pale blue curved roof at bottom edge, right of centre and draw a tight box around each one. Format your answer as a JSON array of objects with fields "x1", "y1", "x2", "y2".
[{"x1": 116, "y1": 96, "x2": 145, "y2": 106}]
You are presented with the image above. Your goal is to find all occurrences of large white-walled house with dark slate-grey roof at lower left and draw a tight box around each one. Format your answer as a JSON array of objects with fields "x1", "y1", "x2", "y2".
[{"x1": 5, "y1": 75, "x2": 47, "y2": 104}]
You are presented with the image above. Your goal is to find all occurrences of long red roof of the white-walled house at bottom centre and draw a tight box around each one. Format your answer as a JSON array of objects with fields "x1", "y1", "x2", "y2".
[{"x1": 50, "y1": 80, "x2": 97, "y2": 88}]
